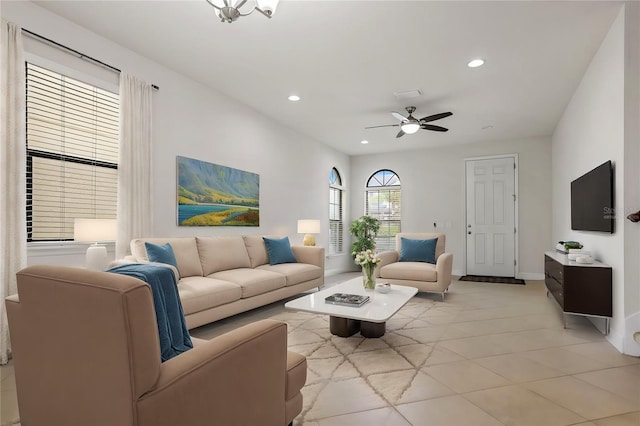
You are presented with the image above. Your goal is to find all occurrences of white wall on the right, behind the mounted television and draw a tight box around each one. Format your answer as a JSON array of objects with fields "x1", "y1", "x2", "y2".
[{"x1": 552, "y1": 5, "x2": 640, "y2": 355}]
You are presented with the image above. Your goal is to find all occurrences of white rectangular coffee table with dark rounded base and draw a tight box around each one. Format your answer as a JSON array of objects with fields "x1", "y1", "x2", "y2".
[{"x1": 284, "y1": 277, "x2": 418, "y2": 337}]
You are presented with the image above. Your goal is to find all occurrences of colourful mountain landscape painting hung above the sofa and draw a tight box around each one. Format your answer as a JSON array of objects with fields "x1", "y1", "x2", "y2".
[{"x1": 176, "y1": 156, "x2": 260, "y2": 226}]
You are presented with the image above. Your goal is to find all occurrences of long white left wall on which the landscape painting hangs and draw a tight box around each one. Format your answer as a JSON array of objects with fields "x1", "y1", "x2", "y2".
[{"x1": 1, "y1": 2, "x2": 350, "y2": 270}]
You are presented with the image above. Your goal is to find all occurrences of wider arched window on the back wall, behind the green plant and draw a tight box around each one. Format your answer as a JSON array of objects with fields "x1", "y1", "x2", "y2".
[{"x1": 364, "y1": 169, "x2": 401, "y2": 252}]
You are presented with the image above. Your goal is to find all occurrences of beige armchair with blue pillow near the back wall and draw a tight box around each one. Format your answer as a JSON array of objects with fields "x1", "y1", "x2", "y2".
[{"x1": 375, "y1": 233, "x2": 453, "y2": 300}]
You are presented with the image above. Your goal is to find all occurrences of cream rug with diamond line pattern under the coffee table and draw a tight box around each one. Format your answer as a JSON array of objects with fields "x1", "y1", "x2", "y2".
[{"x1": 272, "y1": 297, "x2": 458, "y2": 426}]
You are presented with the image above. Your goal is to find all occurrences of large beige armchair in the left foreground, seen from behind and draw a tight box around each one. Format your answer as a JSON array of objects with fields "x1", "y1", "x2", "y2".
[{"x1": 6, "y1": 266, "x2": 307, "y2": 426}]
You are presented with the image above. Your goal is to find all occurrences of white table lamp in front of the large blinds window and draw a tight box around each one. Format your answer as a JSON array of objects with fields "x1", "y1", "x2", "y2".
[{"x1": 73, "y1": 219, "x2": 117, "y2": 271}]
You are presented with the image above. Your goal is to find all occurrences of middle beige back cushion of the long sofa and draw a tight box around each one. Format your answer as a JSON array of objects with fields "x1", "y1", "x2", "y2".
[{"x1": 196, "y1": 236, "x2": 251, "y2": 276}]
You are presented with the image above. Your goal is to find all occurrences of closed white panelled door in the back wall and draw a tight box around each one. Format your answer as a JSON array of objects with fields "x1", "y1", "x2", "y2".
[{"x1": 466, "y1": 157, "x2": 516, "y2": 277}]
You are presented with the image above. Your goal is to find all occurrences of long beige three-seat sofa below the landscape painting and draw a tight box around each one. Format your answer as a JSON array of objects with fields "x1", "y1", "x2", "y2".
[{"x1": 124, "y1": 235, "x2": 324, "y2": 329}]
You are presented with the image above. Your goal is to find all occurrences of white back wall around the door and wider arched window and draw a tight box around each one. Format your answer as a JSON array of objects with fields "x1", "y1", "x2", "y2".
[{"x1": 350, "y1": 138, "x2": 553, "y2": 279}]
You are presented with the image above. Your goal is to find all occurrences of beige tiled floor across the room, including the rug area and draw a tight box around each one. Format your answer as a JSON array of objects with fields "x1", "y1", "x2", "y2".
[{"x1": 0, "y1": 274, "x2": 640, "y2": 426}]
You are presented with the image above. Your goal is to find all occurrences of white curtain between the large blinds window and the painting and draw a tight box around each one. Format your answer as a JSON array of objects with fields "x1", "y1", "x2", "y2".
[{"x1": 116, "y1": 72, "x2": 153, "y2": 259}]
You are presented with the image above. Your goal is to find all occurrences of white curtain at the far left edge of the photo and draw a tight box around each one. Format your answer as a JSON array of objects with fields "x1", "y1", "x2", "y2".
[{"x1": 0, "y1": 20, "x2": 27, "y2": 364}]
